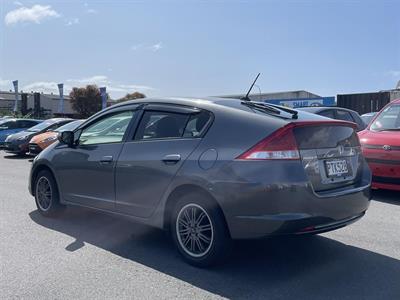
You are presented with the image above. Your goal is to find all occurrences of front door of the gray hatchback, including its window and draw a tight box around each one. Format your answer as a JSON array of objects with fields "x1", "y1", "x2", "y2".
[{"x1": 53, "y1": 110, "x2": 135, "y2": 209}]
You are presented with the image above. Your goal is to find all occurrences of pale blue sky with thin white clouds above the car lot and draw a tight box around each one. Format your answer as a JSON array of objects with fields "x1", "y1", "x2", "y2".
[{"x1": 0, "y1": 0, "x2": 400, "y2": 99}]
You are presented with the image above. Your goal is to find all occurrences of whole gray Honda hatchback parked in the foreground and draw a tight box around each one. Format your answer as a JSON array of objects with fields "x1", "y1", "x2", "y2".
[{"x1": 29, "y1": 98, "x2": 371, "y2": 266}]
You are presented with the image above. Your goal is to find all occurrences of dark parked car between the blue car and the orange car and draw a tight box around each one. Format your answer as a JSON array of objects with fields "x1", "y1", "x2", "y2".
[{"x1": 4, "y1": 118, "x2": 73, "y2": 155}]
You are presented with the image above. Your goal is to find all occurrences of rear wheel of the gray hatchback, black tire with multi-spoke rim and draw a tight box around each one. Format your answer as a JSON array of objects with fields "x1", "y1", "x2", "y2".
[{"x1": 170, "y1": 193, "x2": 232, "y2": 267}]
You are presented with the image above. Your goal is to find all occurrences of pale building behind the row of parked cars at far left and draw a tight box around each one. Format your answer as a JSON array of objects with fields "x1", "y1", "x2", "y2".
[{"x1": 0, "y1": 91, "x2": 76, "y2": 117}]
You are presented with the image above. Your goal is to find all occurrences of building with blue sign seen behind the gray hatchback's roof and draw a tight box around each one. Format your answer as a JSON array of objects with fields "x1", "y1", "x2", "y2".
[{"x1": 220, "y1": 90, "x2": 336, "y2": 107}]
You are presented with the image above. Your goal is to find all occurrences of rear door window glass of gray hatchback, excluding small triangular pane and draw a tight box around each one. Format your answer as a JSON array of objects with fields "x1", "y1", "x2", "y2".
[{"x1": 135, "y1": 111, "x2": 190, "y2": 140}]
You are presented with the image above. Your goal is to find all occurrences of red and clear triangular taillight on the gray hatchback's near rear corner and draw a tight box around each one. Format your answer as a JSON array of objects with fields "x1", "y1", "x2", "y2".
[{"x1": 236, "y1": 124, "x2": 300, "y2": 160}]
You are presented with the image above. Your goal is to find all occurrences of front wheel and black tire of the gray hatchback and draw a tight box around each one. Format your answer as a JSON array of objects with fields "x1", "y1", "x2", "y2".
[{"x1": 34, "y1": 170, "x2": 65, "y2": 217}]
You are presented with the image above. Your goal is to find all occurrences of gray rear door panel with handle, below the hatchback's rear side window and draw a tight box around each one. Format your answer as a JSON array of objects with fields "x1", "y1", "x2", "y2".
[{"x1": 115, "y1": 138, "x2": 200, "y2": 217}]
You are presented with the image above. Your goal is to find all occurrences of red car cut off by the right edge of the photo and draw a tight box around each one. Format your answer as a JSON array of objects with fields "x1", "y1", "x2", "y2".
[{"x1": 358, "y1": 99, "x2": 400, "y2": 191}]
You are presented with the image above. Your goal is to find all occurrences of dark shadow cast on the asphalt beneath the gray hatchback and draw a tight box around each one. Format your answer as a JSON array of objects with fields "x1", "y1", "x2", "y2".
[{"x1": 30, "y1": 207, "x2": 400, "y2": 299}]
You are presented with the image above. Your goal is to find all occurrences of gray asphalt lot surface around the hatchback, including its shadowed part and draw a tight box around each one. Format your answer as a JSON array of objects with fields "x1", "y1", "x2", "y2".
[{"x1": 0, "y1": 152, "x2": 400, "y2": 299}]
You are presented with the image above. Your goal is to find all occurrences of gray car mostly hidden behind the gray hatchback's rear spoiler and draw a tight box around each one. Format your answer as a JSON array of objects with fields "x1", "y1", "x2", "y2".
[{"x1": 298, "y1": 106, "x2": 367, "y2": 131}]
